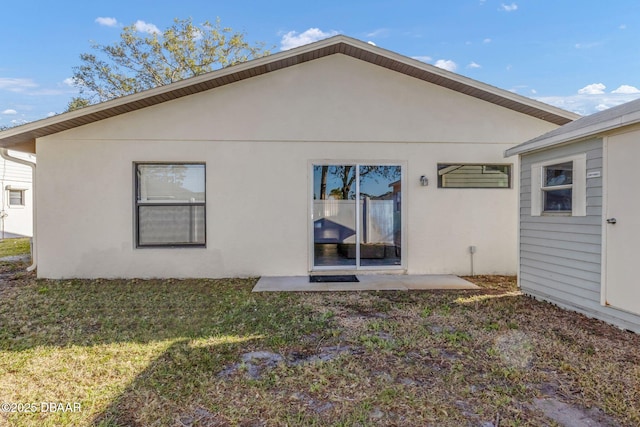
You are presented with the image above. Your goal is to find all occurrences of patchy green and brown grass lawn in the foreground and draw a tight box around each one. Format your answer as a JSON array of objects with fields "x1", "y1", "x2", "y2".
[{"x1": 0, "y1": 275, "x2": 640, "y2": 426}]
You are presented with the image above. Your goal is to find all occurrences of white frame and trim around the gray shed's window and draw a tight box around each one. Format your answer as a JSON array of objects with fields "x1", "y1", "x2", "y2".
[{"x1": 531, "y1": 153, "x2": 587, "y2": 216}]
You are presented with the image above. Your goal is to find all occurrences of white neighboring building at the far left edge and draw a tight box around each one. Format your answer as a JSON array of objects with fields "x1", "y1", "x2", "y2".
[{"x1": 0, "y1": 152, "x2": 35, "y2": 239}]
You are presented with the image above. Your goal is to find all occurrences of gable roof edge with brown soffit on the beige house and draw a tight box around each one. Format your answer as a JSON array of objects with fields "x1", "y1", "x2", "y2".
[{"x1": 0, "y1": 35, "x2": 580, "y2": 151}]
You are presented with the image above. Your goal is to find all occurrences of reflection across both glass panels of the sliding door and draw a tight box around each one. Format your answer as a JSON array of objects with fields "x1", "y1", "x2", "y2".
[{"x1": 313, "y1": 164, "x2": 402, "y2": 269}]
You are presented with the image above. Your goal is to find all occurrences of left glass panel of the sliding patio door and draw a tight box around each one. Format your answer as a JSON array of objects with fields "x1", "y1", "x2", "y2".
[{"x1": 313, "y1": 165, "x2": 357, "y2": 268}]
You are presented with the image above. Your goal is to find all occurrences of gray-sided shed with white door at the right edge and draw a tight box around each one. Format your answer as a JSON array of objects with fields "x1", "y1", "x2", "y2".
[{"x1": 506, "y1": 100, "x2": 640, "y2": 332}]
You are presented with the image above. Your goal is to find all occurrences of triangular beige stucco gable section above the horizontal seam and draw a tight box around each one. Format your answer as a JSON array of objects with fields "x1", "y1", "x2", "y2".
[{"x1": 53, "y1": 55, "x2": 557, "y2": 144}]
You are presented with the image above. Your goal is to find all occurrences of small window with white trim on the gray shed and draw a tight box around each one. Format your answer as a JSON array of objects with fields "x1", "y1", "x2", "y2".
[{"x1": 531, "y1": 154, "x2": 587, "y2": 216}]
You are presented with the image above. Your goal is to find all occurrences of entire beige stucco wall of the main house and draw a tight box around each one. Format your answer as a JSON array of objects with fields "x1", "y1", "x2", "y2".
[{"x1": 36, "y1": 55, "x2": 556, "y2": 278}]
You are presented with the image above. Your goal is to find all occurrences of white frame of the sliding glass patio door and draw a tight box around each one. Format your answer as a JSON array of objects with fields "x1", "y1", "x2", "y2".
[{"x1": 307, "y1": 159, "x2": 408, "y2": 273}]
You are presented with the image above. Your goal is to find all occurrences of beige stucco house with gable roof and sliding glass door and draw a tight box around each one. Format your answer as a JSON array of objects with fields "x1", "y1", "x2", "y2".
[{"x1": 0, "y1": 36, "x2": 578, "y2": 278}]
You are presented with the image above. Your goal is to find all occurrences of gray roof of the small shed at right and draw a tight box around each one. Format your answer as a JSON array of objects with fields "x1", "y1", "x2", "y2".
[{"x1": 505, "y1": 99, "x2": 640, "y2": 157}]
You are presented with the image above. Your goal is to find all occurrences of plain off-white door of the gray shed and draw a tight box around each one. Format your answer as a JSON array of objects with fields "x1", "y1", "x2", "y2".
[{"x1": 604, "y1": 132, "x2": 640, "y2": 314}]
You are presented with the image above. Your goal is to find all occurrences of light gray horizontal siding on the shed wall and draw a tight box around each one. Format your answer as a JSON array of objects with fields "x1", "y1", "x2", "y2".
[{"x1": 519, "y1": 138, "x2": 640, "y2": 331}]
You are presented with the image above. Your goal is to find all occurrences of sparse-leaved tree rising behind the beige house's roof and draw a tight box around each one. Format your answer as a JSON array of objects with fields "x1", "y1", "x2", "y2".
[{"x1": 68, "y1": 18, "x2": 270, "y2": 111}]
